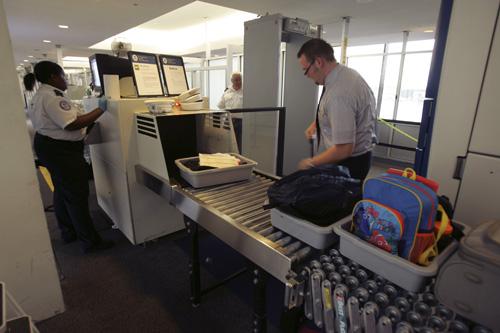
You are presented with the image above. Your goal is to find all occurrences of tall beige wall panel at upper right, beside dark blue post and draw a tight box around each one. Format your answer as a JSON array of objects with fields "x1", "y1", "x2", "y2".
[{"x1": 427, "y1": 0, "x2": 499, "y2": 202}]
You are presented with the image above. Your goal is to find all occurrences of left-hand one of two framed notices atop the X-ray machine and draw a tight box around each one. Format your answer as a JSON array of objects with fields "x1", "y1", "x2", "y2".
[{"x1": 127, "y1": 51, "x2": 164, "y2": 97}]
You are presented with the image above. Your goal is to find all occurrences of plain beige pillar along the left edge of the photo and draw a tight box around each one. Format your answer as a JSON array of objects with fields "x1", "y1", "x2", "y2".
[{"x1": 0, "y1": 1, "x2": 64, "y2": 320}]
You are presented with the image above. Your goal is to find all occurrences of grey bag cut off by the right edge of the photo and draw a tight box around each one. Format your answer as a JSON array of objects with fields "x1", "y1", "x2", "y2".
[{"x1": 434, "y1": 221, "x2": 500, "y2": 332}]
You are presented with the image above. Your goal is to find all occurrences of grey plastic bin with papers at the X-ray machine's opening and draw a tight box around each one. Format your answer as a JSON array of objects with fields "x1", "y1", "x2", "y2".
[{"x1": 175, "y1": 154, "x2": 257, "y2": 188}]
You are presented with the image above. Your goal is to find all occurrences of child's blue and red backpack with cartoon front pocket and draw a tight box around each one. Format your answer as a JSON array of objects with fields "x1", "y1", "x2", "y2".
[{"x1": 352, "y1": 167, "x2": 438, "y2": 263}]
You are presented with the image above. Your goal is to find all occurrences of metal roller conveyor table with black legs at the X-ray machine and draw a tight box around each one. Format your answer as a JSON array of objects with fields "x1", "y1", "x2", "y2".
[{"x1": 136, "y1": 166, "x2": 313, "y2": 332}]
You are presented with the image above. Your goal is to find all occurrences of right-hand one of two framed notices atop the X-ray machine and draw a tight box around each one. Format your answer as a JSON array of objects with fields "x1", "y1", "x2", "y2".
[{"x1": 159, "y1": 54, "x2": 189, "y2": 96}]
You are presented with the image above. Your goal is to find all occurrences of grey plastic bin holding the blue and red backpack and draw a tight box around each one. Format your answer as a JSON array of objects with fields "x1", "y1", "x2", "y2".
[{"x1": 333, "y1": 221, "x2": 465, "y2": 292}]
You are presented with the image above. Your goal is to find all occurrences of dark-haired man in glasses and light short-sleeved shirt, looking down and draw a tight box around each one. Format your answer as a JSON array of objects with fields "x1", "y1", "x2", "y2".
[{"x1": 297, "y1": 38, "x2": 376, "y2": 180}]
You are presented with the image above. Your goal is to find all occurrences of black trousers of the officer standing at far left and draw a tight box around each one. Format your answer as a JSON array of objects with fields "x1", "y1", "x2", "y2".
[{"x1": 34, "y1": 133, "x2": 101, "y2": 248}]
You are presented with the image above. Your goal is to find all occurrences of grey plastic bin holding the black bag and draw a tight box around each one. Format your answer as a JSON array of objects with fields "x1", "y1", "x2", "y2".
[{"x1": 271, "y1": 208, "x2": 351, "y2": 250}]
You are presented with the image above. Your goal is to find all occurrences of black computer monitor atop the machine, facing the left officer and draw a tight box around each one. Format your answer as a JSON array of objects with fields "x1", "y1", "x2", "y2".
[{"x1": 89, "y1": 53, "x2": 132, "y2": 96}]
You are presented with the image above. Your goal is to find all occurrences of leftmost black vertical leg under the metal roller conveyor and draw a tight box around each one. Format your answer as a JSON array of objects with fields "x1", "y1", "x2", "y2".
[{"x1": 184, "y1": 216, "x2": 201, "y2": 307}]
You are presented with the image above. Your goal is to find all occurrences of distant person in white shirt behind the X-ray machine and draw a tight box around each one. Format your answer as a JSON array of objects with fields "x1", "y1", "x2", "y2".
[{"x1": 217, "y1": 72, "x2": 243, "y2": 152}]
